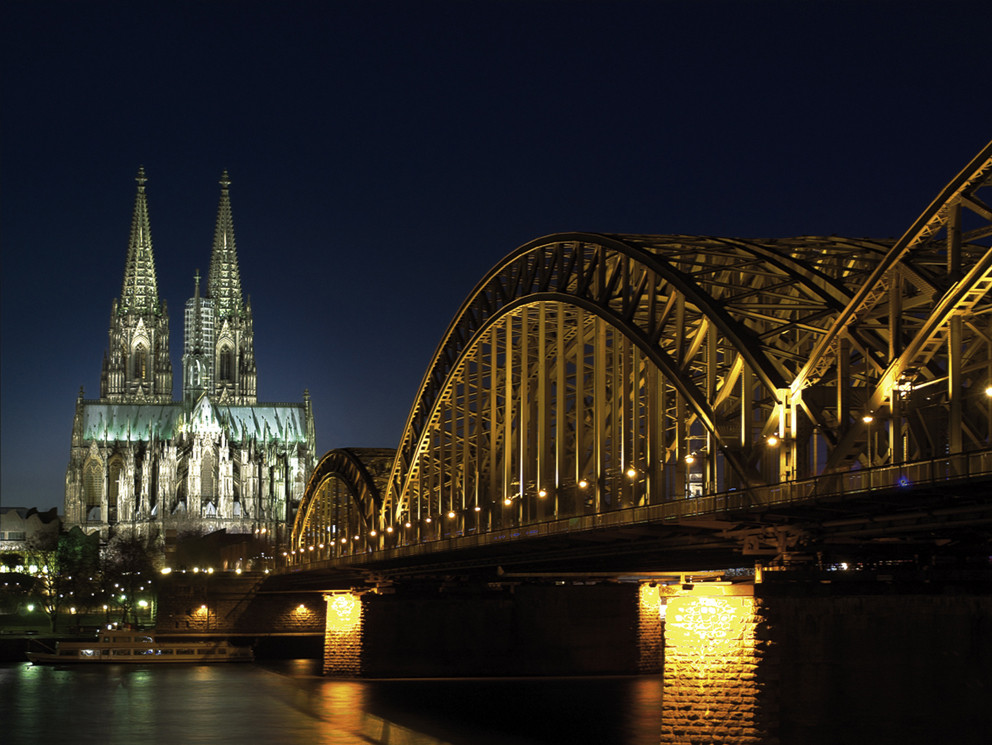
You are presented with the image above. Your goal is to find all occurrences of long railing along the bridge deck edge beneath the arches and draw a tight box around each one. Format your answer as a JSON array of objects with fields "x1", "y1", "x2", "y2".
[{"x1": 287, "y1": 451, "x2": 992, "y2": 566}]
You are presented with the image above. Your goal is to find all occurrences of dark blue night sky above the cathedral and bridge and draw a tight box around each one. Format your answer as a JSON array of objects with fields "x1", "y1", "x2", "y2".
[{"x1": 0, "y1": 0, "x2": 992, "y2": 511}]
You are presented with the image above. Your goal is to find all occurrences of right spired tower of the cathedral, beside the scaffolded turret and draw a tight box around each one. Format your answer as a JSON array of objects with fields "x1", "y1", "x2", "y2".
[{"x1": 207, "y1": 171, "x2": 257, "y2": 405}]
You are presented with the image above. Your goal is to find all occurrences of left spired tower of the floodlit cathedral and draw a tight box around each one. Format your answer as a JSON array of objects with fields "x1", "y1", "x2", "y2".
[{"x1": 100, "y1": 168, "x2": 172, "y2": 403}]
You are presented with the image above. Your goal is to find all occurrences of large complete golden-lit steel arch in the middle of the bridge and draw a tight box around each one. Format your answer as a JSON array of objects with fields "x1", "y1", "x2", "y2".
[{"x1": 382, "y1": 233, "x2": 900, "y2": 531}]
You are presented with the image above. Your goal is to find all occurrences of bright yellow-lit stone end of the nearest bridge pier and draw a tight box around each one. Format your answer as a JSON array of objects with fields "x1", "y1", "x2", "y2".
[{"x1": 661, "y1": 582, "x2": 778, "y2": 745}]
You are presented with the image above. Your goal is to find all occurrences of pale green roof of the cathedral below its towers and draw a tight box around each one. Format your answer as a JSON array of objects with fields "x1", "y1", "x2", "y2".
[{"x1": 82, "y1": 398, "x2": 307, "y2": 444}]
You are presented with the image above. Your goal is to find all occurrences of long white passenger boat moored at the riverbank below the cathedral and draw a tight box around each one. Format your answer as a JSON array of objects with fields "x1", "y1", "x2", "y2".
[{"x1": 27, "y1": 629, "x2": 255, "y2": 665}]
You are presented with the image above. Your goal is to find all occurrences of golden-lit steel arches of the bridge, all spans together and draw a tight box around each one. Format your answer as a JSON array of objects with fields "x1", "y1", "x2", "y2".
[{"x1": 291, "y1": 143, "x2": 992, "y2": 561}]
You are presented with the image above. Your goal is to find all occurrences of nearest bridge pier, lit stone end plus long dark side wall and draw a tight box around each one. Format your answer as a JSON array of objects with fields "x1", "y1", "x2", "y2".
[{"x1": 661, "y1": 572, "x2": 992, "y2": 745}]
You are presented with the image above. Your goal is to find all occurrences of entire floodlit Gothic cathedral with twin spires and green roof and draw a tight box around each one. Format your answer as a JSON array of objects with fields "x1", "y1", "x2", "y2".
[{"x1": 65, "y1": 169, "x2": 315, "y2": 543}]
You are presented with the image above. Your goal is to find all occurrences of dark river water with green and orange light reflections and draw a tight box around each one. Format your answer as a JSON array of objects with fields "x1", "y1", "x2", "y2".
[{"x1": 0, "y1": 660, "x2": 661, "y2": 745}]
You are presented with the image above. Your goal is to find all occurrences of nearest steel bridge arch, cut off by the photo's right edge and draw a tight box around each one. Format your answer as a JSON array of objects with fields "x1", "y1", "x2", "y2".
[{"x1": 791, "y1": 143, "x2": 992, "y2": 470}]
